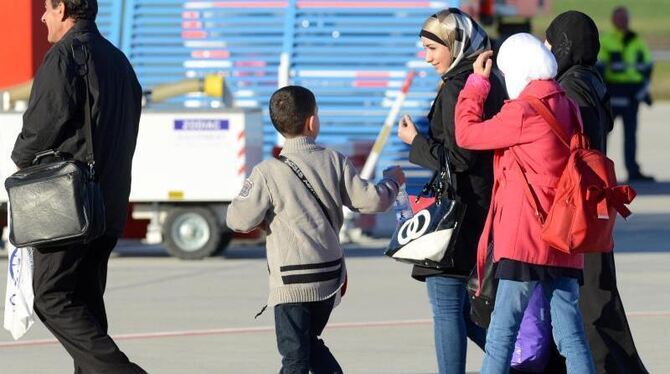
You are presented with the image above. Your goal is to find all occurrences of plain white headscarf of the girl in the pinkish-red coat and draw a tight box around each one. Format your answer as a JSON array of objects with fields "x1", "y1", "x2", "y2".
[{"x1": 497, "y1": 33, "x2": 558, "y2": 99}]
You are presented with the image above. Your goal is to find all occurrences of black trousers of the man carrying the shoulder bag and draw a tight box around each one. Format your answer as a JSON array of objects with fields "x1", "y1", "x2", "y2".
[{"x1": 33, "y1": 236, "x2": 145, "y2": 374}]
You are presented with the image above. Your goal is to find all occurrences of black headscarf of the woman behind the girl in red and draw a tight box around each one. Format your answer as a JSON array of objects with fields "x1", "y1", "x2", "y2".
[{"x1": 546, "y1": 10, "x2": 600, "y2": 77}]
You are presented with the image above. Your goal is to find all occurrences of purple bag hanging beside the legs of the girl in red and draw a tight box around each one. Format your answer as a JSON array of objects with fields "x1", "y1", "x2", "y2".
[{"x1": 511, "y1": 284, "x2": 553, "y2": 373}]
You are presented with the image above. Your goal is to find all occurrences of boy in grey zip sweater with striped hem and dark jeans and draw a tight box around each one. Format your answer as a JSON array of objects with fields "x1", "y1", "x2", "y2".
[{"x1": 226, "y1": 86, "x2": 405, "y2": 374}]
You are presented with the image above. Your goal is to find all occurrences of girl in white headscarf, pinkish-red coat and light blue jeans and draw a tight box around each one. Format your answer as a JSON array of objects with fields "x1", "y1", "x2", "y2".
[{"x1": 456, "y1": 34, "x2": 595, "y2": 374}]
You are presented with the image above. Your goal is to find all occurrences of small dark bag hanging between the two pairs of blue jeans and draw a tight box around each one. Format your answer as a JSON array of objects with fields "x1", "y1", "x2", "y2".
[{"x1": 467, "y1": 242, "x2": 498, "y2": 328}]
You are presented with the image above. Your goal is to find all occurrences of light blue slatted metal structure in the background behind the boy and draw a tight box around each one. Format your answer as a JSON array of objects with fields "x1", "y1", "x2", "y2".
[{"x1": 115, "y1": 0, "x2": 458, "y2": 190}]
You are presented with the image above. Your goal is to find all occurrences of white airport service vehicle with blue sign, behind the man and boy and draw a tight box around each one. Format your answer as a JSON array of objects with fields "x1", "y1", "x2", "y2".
[{"x1": 0, "y1": 108, "x2": 263, "y2": 259}]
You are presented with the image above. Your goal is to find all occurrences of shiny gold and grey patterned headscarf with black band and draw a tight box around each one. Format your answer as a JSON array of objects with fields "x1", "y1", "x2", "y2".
[{"x1": 419, "y1": 8, "x2": 491, "y2": 72}]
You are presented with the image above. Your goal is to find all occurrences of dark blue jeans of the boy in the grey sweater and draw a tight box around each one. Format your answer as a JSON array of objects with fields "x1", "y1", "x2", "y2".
[{"x1": 274, "y1": 296, "x2": 342, "y2": 374}]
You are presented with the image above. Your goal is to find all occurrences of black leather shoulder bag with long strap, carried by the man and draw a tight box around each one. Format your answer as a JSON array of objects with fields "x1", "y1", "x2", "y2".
[{"x1": 5, "y1": 40, "x2": 105, "y2": 248}]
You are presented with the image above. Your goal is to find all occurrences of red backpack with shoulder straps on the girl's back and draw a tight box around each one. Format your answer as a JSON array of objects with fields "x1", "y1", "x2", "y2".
[{"x1": 514, "y1": 96, "x2": 635, "y2": 254}]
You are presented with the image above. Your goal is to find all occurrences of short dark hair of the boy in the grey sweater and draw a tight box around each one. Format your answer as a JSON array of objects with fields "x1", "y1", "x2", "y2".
[{"x1": 270, "y1": 86, "x2": 316, "y2": 137}]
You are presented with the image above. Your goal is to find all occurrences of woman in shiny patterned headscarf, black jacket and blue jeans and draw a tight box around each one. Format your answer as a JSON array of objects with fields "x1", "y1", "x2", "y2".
[{"x1": 398, "y1": 8, "x2": 504, "y2": 374}]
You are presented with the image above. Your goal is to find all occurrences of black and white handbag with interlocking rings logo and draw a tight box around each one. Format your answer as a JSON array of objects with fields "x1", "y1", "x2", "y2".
[{"x1": 385, "y1": 151, "x2": 467, "y2": 269}]
